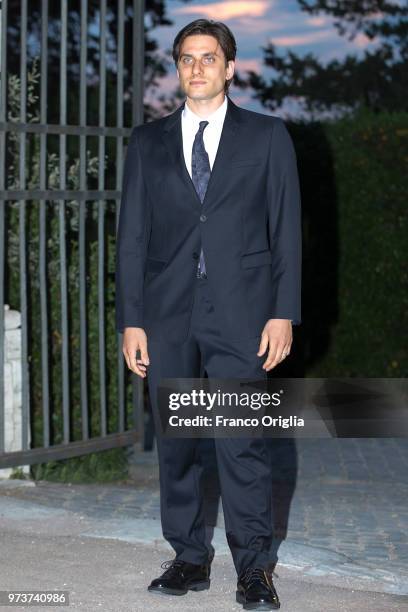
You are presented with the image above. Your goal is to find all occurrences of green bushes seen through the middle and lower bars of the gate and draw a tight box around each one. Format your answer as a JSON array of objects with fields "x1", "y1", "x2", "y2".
[{"x1": 5, "y1": 59, "x2": 132, "y2": 480}]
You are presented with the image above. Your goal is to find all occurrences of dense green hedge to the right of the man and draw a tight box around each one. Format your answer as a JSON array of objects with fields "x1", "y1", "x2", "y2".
[{"x1": 291, "y1": 112, "x2": 408, "y2": 377}]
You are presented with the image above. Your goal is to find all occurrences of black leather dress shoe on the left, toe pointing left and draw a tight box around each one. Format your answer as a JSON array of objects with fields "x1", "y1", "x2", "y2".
[{"x1": 147, "y1": 559, "x2": 210, "y2": 595}]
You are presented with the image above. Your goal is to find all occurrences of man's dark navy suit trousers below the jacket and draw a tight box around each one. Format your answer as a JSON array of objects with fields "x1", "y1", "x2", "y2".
[{"x1": 148, "y1": 279, "x2": 272, "y2": 573}]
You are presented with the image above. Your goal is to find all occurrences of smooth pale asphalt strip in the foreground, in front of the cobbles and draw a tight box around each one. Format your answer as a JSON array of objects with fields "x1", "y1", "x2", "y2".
[{"x1": 0, "y1": 524, "x2": 408, "y2": 612}]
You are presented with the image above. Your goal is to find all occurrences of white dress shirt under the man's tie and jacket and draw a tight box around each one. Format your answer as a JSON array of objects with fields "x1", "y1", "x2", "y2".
[{"x1": 181, "y1": 96, "x2": 228, "y2": 176}]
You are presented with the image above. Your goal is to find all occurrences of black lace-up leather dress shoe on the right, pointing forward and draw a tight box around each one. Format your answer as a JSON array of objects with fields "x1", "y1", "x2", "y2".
[{"x1": 236, "y1": 567, "x2": 280, "y2": 610}]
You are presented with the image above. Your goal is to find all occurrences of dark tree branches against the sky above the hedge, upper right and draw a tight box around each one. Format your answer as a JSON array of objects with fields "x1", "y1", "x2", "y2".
[{"x1": 237, "y1": 0, "x2": 408, "y2": 115}]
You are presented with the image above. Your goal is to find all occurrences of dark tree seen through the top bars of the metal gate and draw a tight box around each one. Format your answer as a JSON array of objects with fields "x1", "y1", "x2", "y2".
[{"x1": 7, "y1": 0, "x2": 190, "y2": 125}]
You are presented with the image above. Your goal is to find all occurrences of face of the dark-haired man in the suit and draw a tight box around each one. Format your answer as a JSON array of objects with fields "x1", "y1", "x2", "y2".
[{"x1": 177, "y1": 34, "x2": 235, "y2": 100}]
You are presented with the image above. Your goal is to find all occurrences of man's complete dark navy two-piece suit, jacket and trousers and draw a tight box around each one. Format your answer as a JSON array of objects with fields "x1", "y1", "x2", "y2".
[{"x1": 116, "y1": 99, "x2": 301, "y2": 573}]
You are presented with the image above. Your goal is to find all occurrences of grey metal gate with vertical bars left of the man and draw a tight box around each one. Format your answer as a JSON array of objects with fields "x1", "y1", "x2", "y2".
[{"x1": 0, "y1": 0, "x2": 144, "y2": 467}]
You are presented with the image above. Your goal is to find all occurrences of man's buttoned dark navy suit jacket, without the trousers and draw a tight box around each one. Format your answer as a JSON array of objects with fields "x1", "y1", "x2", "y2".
[{"x1": 116, "y1": 98, "x2": 301, "y2": 343}]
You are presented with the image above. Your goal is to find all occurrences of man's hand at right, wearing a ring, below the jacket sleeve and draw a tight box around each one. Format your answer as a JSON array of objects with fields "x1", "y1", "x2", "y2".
[{"x1": 257, "y1": 319, "x2": 293, "y2": 372}]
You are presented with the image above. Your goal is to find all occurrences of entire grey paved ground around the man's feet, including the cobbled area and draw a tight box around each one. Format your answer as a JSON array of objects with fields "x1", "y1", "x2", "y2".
[{"x1": 0, "y1": 440, "x2": 408, "y2": 612}]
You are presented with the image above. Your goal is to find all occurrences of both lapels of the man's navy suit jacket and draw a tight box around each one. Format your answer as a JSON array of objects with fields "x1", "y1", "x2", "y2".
[{"x1": 163, "y1": 98, "x2": 240, "y2": 207}]
